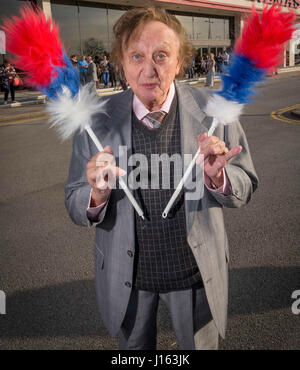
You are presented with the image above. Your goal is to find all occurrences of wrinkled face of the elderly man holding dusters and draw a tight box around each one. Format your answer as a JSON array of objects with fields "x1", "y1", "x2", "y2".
[{"x1": 122, "y1": 21, "x2": 181, "y2": 110}]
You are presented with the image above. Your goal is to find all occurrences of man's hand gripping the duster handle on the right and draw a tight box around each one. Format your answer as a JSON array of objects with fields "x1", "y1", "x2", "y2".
[{"x1": 198, "y1": 133, "x2": 242, "y2": 188}]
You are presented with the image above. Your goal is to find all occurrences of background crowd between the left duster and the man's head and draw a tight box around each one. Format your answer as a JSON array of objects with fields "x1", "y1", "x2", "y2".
[{"x1": 70, "y1": 54, "x2": 127, "y2": 90}]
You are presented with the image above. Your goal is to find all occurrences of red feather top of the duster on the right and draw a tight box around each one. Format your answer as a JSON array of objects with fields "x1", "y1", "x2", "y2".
[{"x1": 234, "y1": 5, "x2": 295, "y2": 69}]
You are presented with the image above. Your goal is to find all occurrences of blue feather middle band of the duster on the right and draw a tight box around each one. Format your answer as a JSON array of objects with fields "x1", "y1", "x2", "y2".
[{"x1": 216, "y1": 54, "x2": 266, "y2": 104}]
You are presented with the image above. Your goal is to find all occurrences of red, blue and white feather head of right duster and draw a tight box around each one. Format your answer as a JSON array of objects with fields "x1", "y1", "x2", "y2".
[{"x1": 205, "y1": 5, "x2": 295, "y2": 134}]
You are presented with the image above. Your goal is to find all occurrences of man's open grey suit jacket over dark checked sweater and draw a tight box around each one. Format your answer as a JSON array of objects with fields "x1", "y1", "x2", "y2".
[{"x1": 65, "y1": 81, "x2": 258, "y2": 338}]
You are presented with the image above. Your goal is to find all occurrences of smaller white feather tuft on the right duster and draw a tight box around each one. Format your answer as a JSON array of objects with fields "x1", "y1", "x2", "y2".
[{"x1": 204, "y1": 94, "x2": 244, "y2": 125}]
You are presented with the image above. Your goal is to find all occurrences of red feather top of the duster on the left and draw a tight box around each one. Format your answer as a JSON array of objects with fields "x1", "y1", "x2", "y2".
[{"x1": 2, "y1": 6, "x2": 65, "y2": 86}]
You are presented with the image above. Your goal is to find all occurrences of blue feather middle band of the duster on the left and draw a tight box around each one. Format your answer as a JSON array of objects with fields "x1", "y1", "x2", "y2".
[{"x1": 40, "y1": 50, "x2": 80, "y2": 100}]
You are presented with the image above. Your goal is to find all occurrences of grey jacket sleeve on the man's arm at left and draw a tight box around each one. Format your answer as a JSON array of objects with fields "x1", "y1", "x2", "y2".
[{"x1": 65, "y1": 131, "x2": 108, "y2": 227}]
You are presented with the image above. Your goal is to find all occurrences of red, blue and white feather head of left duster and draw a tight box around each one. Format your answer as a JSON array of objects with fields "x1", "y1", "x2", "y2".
[{"x1": 3, "y1": 6, "x2": 103, "y2": 142}]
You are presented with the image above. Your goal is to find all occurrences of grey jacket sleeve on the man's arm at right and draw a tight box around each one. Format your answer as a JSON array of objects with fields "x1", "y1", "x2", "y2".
[{"x1": 210, "y1": 121, "x2": 258, "y2": 208}]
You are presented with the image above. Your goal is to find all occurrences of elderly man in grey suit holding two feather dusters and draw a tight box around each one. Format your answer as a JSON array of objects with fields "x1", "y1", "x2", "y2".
[{"x1": 66, "y1": 8, "x2": 257, "y2": 349}]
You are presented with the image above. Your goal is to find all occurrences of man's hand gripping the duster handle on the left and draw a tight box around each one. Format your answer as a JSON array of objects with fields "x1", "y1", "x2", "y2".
[{"x1": 86, "y1": 146, "x2": 126, "y2": 207}]
